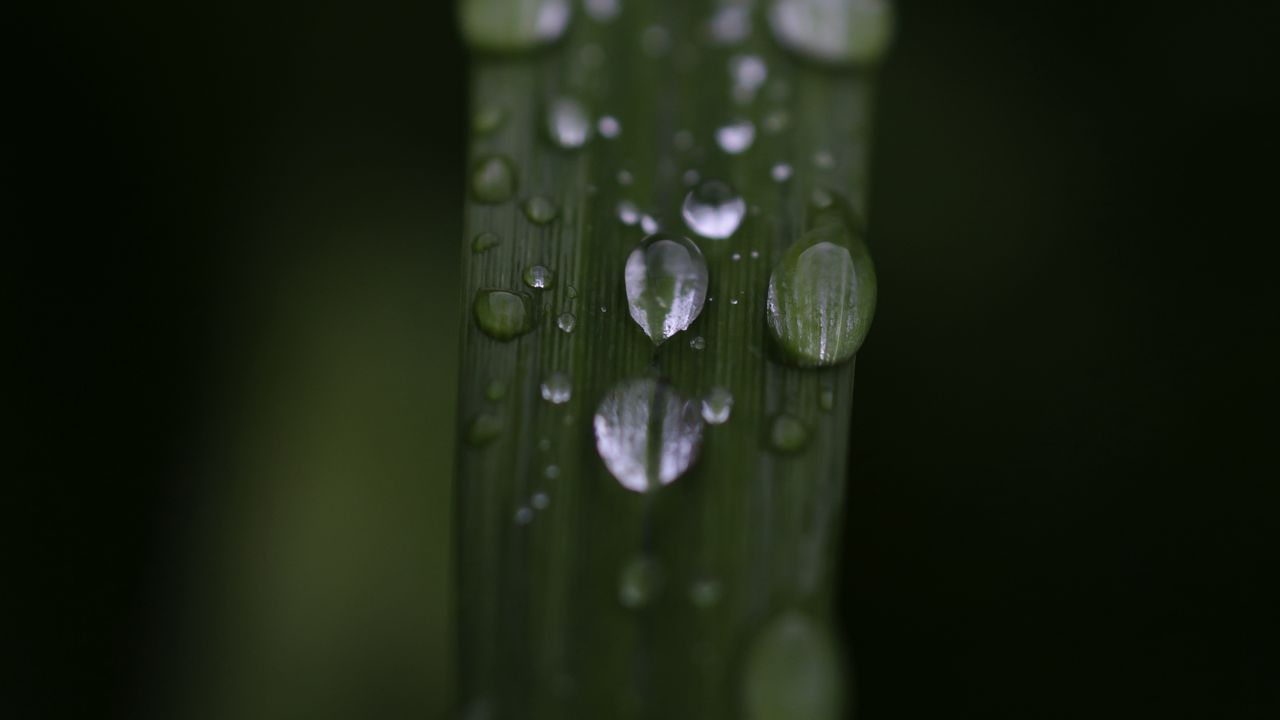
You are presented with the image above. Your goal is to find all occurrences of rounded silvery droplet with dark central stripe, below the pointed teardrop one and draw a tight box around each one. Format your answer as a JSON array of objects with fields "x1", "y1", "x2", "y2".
[{"x1": 594, "y1": 379, "x2": 703, "y2": 492}]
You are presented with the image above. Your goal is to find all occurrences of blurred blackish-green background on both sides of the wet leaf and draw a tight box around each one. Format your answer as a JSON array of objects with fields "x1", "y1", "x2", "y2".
[{"x1": 20, "y1": 1, "x2": 1280, "y2": 720}]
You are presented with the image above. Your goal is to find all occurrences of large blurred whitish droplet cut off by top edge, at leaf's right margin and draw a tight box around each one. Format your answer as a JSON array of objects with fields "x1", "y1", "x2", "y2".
[{"x1": 769, "y1": 0, "x2": 893, "y2": 65}]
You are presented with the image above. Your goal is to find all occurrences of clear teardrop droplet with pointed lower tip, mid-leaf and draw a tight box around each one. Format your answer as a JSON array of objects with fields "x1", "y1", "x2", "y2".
[{"x1": 625, "y1": 234, "x2": 708, "y2": 345}]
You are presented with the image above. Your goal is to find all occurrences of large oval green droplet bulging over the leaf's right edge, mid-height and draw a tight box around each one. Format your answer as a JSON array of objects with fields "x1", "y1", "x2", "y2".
[{"x1": 767, "y1": 199, "x2": 876, "y2": 366}]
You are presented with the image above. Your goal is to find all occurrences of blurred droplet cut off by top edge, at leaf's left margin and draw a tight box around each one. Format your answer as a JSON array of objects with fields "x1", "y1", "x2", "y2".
[{"x1": 458, "y1": 0, "x2": 573, "y2": 53}]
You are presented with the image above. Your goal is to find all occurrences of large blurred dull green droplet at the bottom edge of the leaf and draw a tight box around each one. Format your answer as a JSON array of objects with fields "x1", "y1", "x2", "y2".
[{"x1": 742, "y1": 610, "x2": 844, "y2": 720}]
